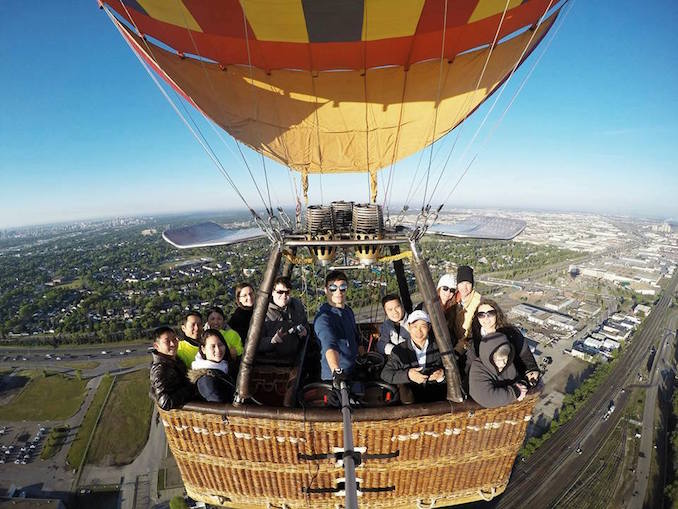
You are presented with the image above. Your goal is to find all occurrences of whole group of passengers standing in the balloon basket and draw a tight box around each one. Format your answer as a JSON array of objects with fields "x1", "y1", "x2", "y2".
[{"x1": 151, "y1": 266, "x2": 540, "y2": 409}]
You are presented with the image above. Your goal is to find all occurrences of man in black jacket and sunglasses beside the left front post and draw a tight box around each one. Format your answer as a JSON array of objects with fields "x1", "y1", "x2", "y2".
[{"x1": 257, "y1": 276, "x2": 308, "y2": 361}]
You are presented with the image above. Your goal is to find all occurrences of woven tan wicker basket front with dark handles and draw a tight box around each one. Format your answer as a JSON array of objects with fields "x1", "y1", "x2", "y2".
[{"x1": 159, "y1": 394, "x2": 538, "y2": 509}]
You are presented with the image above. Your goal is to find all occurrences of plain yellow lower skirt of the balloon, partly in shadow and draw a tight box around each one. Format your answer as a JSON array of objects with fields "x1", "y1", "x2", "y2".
[{"x1": 131, "y1": 12, "x2": 555, "y2": 173}]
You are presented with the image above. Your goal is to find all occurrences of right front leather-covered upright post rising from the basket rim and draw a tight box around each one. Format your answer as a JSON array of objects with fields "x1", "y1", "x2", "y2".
[{"x1": 410, "y1": 242, "x2": 464, "y2": 403}]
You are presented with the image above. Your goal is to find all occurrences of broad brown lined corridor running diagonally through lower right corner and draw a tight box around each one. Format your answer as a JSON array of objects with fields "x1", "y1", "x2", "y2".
[{"x1": 493, "y1": 272, "x2": 678, "y2": 508}]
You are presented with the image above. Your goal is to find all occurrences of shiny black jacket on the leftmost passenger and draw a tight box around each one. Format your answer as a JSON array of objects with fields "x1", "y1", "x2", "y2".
[{"x1": 151, "y1": 350, "x2": 195, "y2": 410}]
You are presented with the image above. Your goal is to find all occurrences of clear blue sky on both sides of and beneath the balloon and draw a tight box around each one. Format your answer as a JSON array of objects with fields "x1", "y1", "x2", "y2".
[{"x1": 0, "y1": 0, "x2": 678, "y2": 228}]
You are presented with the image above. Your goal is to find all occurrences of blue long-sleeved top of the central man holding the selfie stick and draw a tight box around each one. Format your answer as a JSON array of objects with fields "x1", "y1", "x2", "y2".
[{"x1": 313, "y1": 303, "x2": 358, "y2": 380}]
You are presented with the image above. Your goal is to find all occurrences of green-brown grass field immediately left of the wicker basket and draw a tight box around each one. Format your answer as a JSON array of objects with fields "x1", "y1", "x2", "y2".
[{"x1": 87, "y1": 369, "x2": 153, "y2": 465}]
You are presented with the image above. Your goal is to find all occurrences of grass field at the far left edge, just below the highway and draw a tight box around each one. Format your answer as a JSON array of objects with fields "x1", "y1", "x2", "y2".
[{"x1": 0, "y1": 372, "x2": 86, "y2": 421}]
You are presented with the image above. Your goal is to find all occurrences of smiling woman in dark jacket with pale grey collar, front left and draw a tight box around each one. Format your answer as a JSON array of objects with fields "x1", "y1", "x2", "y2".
[{"x1": 188, "y1": 329, "x2": 235, "y2": 403}]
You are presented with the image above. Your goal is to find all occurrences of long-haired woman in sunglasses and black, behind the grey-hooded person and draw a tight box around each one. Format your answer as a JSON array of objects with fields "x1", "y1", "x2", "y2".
[{"x1": 466, "y1": 297, "x2": 541, "y2": 386}]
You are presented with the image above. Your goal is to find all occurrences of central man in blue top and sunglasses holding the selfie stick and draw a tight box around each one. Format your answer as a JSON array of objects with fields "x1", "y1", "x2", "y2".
[{"x1": 313, "y1": 270, "x2": 358, "y2": 383}]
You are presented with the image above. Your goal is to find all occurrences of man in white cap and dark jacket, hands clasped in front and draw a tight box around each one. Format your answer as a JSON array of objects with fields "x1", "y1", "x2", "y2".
[{"x1": 381, "y1": 310, "x2": 445, "y2": 404}]
